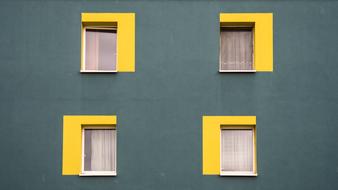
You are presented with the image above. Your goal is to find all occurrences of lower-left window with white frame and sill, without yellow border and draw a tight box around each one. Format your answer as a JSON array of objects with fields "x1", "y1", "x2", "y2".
[{"x1": 80, "y1": 126, "x2": 116, "y2": 175}]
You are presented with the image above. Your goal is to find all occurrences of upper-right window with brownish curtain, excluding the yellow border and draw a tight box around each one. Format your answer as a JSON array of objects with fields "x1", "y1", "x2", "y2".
[{"x1": 220, "y1": 27, "x2": 254, "y2": 72}]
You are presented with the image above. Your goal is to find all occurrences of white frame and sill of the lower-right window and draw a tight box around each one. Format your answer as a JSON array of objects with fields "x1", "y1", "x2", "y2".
[{"x1": 219, "y1": 125, "x2": 258, "y2": 177}]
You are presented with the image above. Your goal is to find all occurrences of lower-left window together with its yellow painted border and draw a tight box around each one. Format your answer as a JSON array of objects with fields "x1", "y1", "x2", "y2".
[{"x1": 62, "y1": 115, "x2": 117, "y2": 176}]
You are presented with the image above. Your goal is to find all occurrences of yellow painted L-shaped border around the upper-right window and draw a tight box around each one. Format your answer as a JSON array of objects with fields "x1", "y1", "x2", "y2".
[{"x1": 220, "y1": 13, "x2": 273, "y2": 72}]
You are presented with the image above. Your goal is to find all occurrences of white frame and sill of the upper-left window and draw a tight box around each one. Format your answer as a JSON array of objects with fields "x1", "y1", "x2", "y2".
[{"x1": 80, "y1": 26, "x2": 118, "y2": 73}]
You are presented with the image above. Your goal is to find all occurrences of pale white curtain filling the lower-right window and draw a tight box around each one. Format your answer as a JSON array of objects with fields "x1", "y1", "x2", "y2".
[{"x1": 221, "y1": 129, "x2": 253, "y2": 171}]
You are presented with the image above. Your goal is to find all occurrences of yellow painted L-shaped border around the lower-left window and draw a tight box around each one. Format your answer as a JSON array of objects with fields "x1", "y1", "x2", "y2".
[{"x1": 62, "y1": 115, "x2": 117, "y2": 175}]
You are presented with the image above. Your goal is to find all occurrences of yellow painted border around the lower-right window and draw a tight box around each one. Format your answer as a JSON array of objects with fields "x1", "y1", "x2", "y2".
[{"x1": 202, "y1": 116, "x2": 257, "y2": 175}]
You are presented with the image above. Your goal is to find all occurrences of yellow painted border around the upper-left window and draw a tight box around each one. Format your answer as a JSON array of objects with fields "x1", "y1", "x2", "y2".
[{"x1": 81, "y1": 13, "x2": 135, "y2": 72}]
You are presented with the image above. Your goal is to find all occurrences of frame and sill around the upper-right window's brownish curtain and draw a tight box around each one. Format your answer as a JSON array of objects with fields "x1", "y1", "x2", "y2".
[{"x1": 218, "y1": 25, "x2": 256, "y2": 73}]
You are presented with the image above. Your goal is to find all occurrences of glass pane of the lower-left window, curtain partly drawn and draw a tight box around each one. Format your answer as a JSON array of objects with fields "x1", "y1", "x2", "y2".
[{"x1": 84, "y1": 129, "x2": 116, "y2": 171}]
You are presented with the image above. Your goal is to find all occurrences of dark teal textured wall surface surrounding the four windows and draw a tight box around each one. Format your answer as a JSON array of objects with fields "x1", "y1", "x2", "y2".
[{"x1": 0, "y1": 0, "x2": 338, "y2": 190}]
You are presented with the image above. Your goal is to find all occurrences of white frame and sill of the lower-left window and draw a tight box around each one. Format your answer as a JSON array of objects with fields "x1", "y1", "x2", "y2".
[{"x1": 79, "y1": 125, "x2": 117, "y2": 176}]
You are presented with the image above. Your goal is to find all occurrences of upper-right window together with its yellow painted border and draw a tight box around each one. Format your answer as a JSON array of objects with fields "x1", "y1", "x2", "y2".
[{"x1": 219, "y1": 13, "x2": 273, "y2": 72}]
